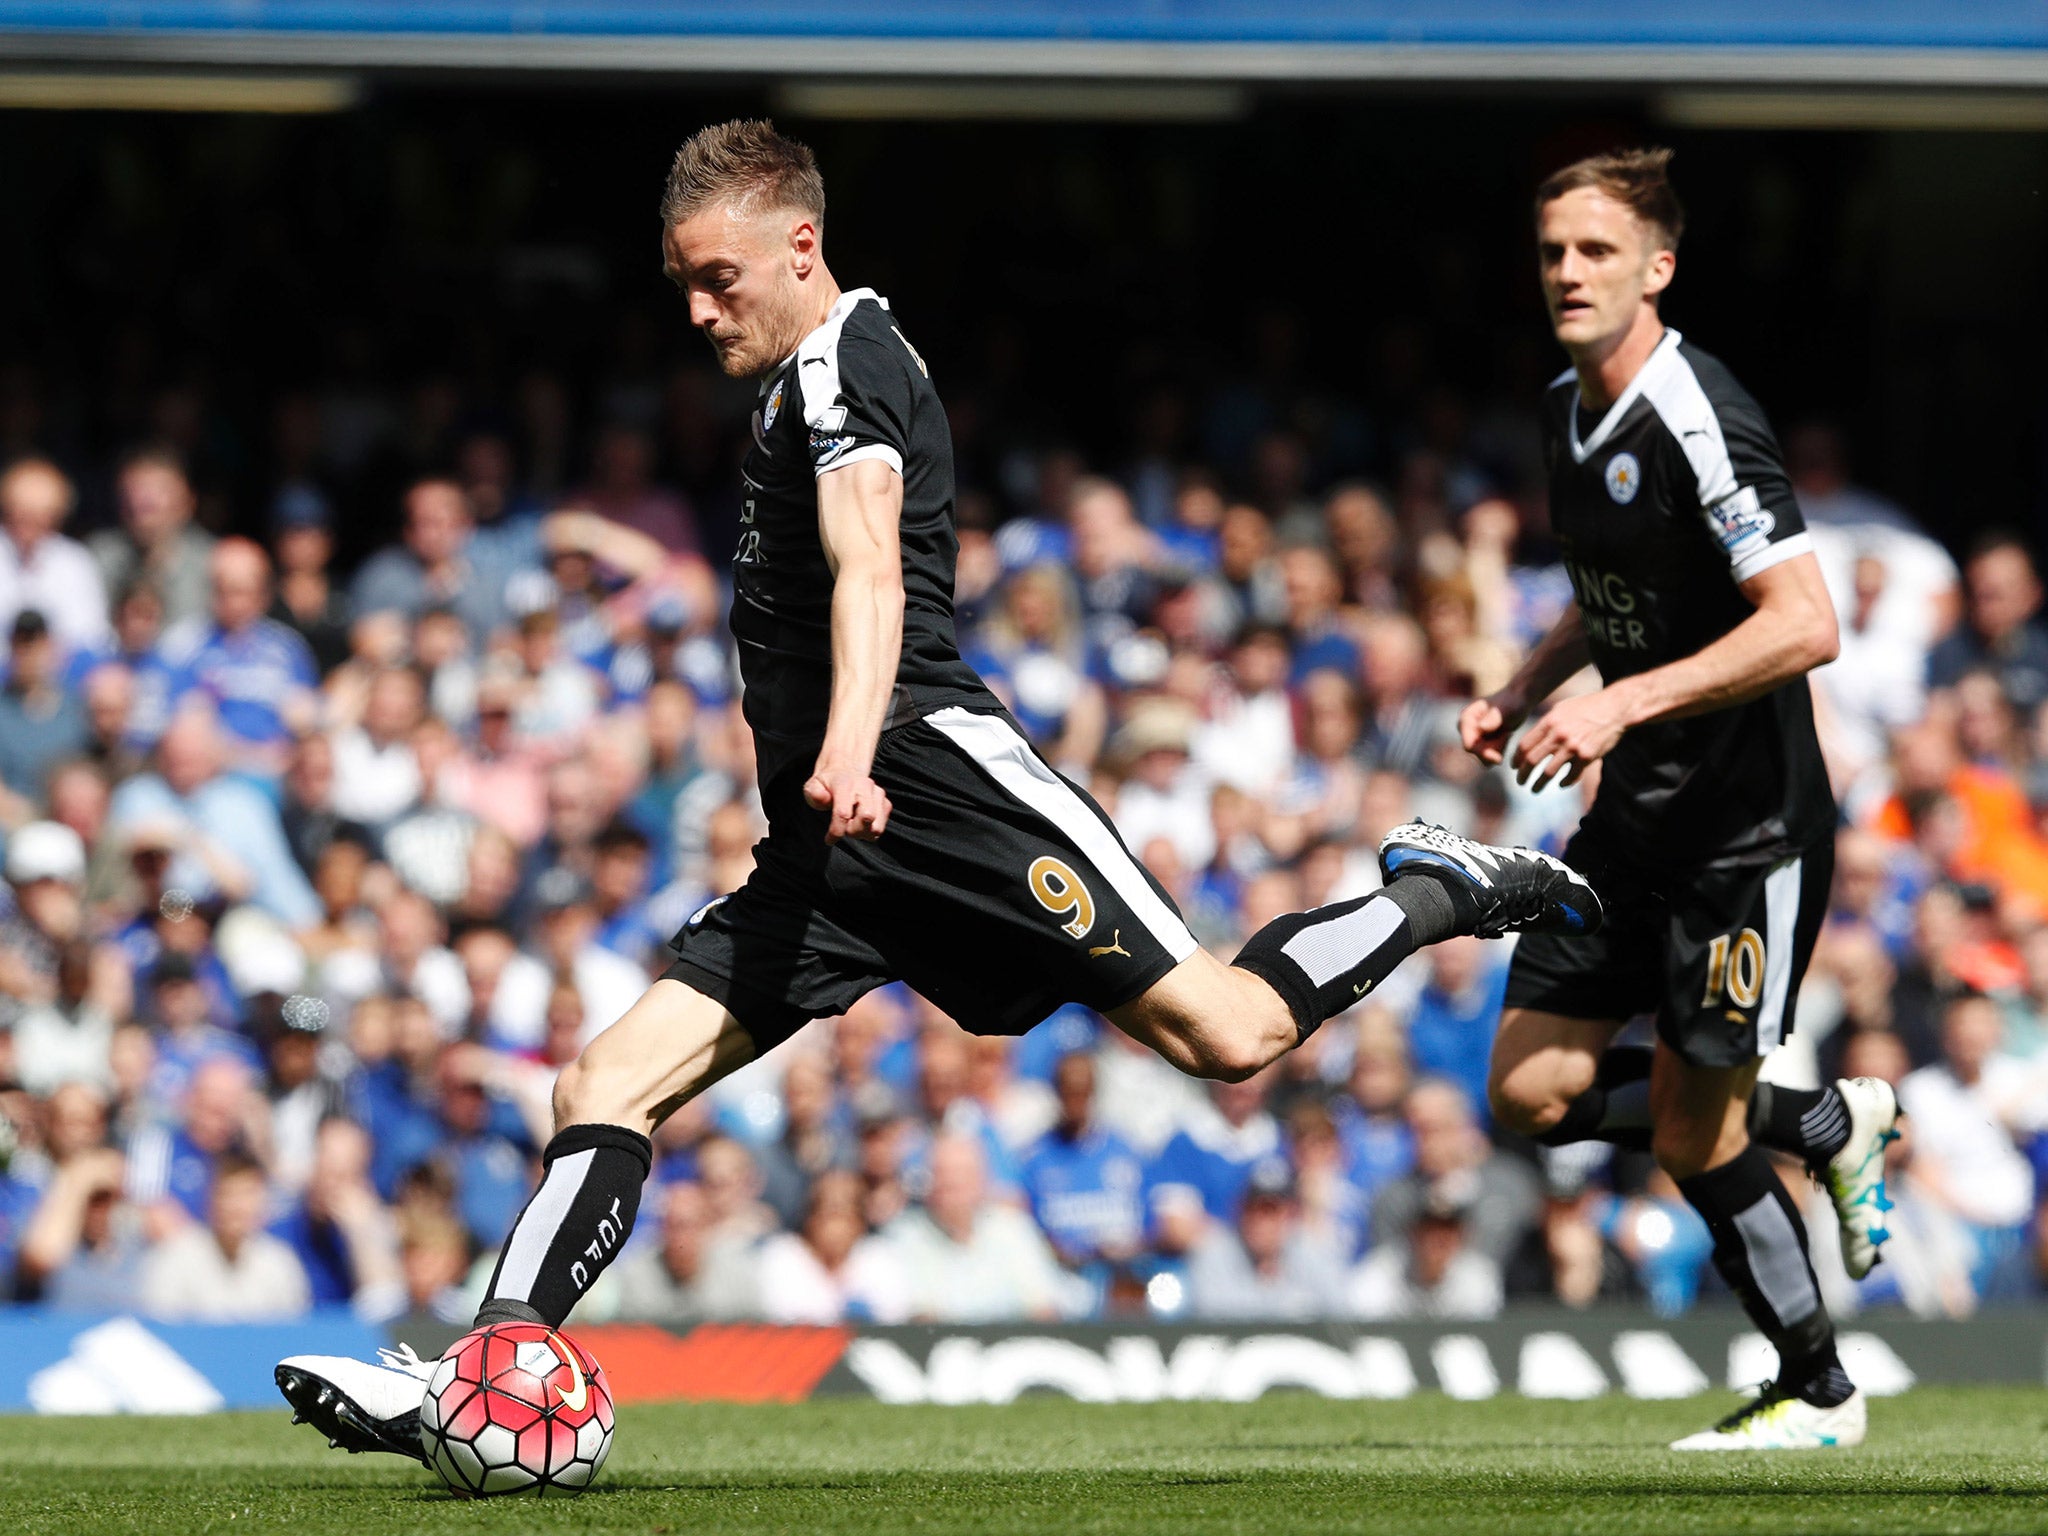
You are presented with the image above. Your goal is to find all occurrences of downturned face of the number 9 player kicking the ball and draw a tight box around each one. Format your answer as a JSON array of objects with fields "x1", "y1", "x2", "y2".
[{"x1": 662, "y1": 207, "x2": 817, "y2": 379}]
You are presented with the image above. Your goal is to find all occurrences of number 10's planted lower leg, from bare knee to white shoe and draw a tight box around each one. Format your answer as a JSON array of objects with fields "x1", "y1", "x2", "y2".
[{"x1": 1651, "y1": 1044, "x2": 1864, "y2": 1450}]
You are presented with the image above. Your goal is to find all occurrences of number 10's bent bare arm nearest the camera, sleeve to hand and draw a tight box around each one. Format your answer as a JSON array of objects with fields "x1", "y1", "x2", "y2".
[{"x1": 1513, "y1": 553, "x2": 1841, "y2": 788}]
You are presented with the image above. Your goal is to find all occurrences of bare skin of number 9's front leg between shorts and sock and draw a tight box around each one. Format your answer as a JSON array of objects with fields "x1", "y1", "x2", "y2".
[{"x1": 555, "y1": 977, "x2": 754, "y2": 1135}]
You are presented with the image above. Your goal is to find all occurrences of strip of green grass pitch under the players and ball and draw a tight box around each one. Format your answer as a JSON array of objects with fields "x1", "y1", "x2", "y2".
[{"x1": 12, "y1": 1389, "x2": 2048, "y2": 1536}]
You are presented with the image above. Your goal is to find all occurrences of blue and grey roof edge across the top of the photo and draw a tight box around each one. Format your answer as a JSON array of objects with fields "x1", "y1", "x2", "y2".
[{"x1": 0, "y1": 0, "x2": 2048, "y2": 88}]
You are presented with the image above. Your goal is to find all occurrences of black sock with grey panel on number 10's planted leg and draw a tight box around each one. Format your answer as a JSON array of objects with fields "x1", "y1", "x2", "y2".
[{"x1": 1677, "y1": 1143, "x2": 1855, "y2": 1407}]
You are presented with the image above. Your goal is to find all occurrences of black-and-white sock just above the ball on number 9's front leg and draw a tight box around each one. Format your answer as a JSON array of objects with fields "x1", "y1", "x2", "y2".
[{"x1": 477, "y1": 1124, "x2": 653, "y2": 1327}]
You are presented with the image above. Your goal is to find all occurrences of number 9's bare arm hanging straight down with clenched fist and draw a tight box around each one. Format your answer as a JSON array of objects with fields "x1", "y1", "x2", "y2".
[{"x1": 803, "y1": 459, "x2": 903, "y2": 842}]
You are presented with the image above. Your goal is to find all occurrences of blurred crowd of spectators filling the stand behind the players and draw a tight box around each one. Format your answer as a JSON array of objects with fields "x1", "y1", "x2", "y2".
[{"x1": 0, "y1": 339, "x2": 2048, "y2": 1323}]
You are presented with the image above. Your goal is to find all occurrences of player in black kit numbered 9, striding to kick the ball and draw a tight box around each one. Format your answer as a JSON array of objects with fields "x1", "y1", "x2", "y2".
[{"x1": 276, "y1": 123, "x2": 1599, "y2": 1456}]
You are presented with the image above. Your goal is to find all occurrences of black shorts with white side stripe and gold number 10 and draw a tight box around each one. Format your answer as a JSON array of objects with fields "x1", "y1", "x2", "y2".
[{"x1": 1507, "y1": 827, "x2": 1835, "y2": 1067}]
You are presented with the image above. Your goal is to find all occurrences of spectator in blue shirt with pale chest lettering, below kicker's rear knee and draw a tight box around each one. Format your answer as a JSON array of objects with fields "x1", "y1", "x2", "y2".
[{"x1": 1024, "y1": 1051, "x2": 1145, "y2": 1294}]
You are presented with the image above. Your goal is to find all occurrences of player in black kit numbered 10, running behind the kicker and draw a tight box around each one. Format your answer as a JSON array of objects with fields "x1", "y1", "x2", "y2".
[{"x1": 1417, "y1": 150, "x2": 1898, "y2": 1450}]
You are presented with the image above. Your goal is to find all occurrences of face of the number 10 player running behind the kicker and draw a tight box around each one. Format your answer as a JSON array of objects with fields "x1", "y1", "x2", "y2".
[{"x1": 1536, "y1": 186, "x2": 1677, "y2": 350}]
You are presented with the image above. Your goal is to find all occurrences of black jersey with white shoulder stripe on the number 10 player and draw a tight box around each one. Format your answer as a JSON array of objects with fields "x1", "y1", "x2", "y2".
[{"x1": 1542, "y1": 330, "x2": 1835, "y2": 864}]
